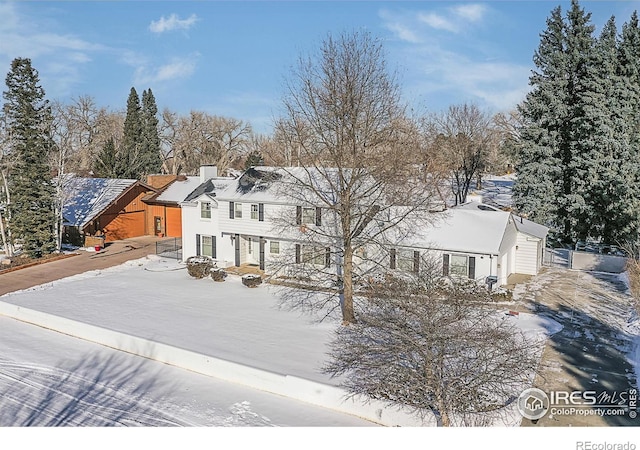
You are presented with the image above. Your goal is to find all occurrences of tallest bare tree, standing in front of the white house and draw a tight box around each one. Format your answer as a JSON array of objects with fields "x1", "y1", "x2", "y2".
[{"x1": 276, "y1": 32, "x2": 431, "y2": 324}]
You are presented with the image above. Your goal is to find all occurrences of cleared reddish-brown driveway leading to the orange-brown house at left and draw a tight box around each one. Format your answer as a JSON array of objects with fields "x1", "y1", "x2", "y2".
[{"x1": 0, "y1": 236, "x2": 160, "y2": 295}]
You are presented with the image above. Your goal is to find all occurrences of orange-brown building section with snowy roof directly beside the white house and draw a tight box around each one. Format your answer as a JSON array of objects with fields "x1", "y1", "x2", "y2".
[{"x1": 142, "y1": 175, "x2": 200, "y2": 237}]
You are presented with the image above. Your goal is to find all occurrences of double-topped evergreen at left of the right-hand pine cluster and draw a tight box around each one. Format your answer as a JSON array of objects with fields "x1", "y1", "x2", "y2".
[{"x1": 514, "y1": 0, "x2": 600, "y2": 243}]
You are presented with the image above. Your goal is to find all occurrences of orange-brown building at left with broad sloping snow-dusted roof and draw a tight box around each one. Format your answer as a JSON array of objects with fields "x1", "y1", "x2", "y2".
[{"x1": 62, "y1": 177, "x2": 156, "y2": 245}]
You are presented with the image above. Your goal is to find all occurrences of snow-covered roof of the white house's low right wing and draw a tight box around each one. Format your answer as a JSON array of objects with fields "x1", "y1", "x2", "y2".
[{"x1": 402, "y1": 204, "x2": 511, "y2": 255}]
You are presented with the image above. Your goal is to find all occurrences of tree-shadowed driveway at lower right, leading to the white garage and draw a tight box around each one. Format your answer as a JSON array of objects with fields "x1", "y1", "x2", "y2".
[{"x1": 514, "y1": 268, "x2": 640, "y2": 426}]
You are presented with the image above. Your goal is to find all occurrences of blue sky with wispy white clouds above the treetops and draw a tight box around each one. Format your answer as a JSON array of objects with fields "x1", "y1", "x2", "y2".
[{"x1": 0, "y1": 0, "x2": 640, "y2": 133}]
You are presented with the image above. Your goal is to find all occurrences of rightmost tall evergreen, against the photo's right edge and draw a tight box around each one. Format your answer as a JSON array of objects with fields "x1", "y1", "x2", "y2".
[{"x1": 582, "y1": 17, "x2": 640, "y2": 243}]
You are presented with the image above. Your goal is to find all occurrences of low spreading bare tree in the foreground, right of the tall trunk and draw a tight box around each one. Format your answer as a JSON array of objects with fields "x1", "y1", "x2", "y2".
[{"x1": 324, "y1": 275, "x2": 541, "y2": 426}]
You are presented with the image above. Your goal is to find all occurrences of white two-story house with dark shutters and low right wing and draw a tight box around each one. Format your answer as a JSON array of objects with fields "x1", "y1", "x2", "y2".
[{"x1": 182, "y1": 167, "x2": 548, "y2": 285}]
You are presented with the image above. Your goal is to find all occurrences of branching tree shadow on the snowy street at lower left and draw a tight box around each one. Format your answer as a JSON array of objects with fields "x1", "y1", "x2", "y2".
[{"x1": 0, "y1": 353, "x2": 187, "y2": 427}]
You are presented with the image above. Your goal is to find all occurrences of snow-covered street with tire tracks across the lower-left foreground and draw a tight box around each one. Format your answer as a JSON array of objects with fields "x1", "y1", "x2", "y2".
[{"x1": 0, "y1": 317, "x2": 373, "y2": 427}]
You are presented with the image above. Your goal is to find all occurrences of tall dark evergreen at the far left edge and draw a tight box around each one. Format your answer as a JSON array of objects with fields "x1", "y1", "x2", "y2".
[{"x1": 3, "y1": 58, "x2": 56, "y2": 257}]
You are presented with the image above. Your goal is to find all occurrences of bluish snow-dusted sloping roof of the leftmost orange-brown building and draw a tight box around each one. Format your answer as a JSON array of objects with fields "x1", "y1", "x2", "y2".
[{"x1": 62, "y1": 177, "x2": 138, "y2": 228}]
